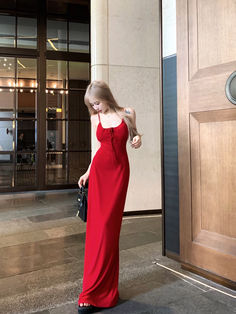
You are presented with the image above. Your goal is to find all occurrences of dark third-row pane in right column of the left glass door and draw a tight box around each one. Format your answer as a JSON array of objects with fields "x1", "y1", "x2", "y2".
[{"x1": 16, "y1": 120, "x2": 36, "y2": 151}]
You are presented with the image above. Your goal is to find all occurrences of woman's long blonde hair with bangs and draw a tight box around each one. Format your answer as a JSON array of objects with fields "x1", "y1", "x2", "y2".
[{"x1": 84, "y1": 80, "x2": 143, "y2": 141}]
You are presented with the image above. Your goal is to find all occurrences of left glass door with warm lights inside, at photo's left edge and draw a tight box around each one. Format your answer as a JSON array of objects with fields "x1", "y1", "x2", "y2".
[{"x1": 0, "y1": 57, "x2": 38, "y2": 189}]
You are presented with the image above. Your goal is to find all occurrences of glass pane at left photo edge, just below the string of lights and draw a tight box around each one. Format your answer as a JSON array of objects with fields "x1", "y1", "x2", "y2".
[{"x1": 0, "y1": 88, "x2": 14, "y2": 118}]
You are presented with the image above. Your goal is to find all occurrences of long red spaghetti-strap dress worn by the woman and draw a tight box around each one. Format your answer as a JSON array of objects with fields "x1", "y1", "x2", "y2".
[{"x1": 78, "y1": 113, "x2": 130, "y2": 307}]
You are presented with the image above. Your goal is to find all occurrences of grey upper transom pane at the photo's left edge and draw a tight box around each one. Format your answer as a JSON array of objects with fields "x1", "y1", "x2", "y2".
[{"x1": 0, "y1": 15, "x2": 16, "y2": 47}]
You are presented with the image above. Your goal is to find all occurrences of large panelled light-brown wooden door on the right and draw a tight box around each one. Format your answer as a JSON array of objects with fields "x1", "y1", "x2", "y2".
[{"x1": 176, "y1": 0, "x2": 236, "y2": 281}]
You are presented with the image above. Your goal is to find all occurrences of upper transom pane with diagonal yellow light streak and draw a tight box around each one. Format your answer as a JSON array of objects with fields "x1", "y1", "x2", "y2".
[{"x1": 47, "y1": 20, "x2": 67, "y2": 51}]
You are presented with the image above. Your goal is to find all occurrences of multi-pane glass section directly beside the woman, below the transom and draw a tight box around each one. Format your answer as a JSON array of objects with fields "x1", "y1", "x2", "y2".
[{"x1": 46, "y1": 60, "x2": 91, "y2": 184}]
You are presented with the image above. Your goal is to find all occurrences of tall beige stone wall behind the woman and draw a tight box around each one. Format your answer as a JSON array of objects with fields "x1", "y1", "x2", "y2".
[{"x1": 91, "y1": 0, "x2": 161, "y2": 211}]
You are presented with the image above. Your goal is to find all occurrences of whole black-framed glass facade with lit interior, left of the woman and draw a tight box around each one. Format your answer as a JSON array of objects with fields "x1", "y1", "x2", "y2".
[{"x1": 0, "y1": 1, "x2": 91, "y2": 192}]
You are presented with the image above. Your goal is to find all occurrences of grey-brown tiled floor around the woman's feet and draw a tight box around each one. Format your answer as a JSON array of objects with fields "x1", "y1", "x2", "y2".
[{"x1": 0, "y1": 192, "x2": 236, "y2": 314}]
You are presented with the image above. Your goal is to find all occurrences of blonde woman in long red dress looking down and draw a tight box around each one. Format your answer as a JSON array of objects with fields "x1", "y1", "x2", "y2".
[{"x1": 78, "y1": 81, "x2": 142, "y2": 313}]
